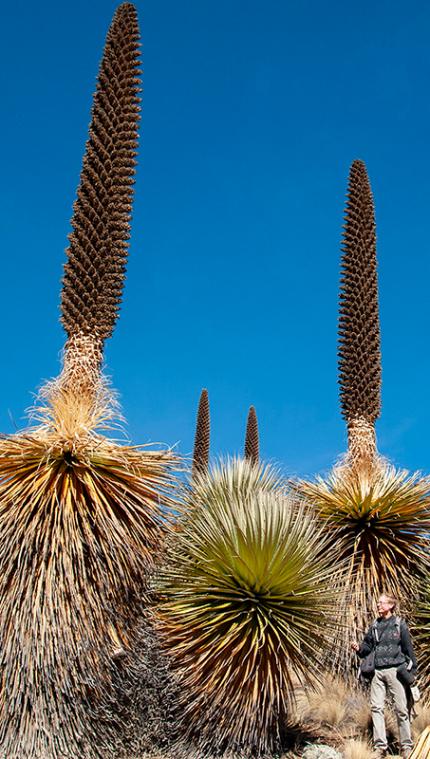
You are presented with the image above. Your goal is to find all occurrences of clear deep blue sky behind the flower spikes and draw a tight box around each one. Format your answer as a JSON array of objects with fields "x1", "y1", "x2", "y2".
[{"x1": 0, "y1": 0, "x2": 430, "y2": 475}]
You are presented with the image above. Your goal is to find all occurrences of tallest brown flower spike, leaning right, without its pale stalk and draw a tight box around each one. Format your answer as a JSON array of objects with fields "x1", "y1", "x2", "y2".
[{"x1": 61, "y1": 3, "x2": 140, "y2": 344}]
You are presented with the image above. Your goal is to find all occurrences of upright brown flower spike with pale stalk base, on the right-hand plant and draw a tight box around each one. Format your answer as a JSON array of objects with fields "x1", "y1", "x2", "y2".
[{"x1": 338, "y1": 161, "x2": 381, "y2": 466}]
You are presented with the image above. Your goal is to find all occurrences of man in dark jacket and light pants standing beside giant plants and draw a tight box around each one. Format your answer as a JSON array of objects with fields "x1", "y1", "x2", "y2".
[{"x1": 352, "y1": 594, "x2": 417, "y2": 759}]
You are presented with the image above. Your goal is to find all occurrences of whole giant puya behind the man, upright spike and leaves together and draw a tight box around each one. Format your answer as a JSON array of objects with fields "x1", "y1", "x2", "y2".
[{"x1": 300, "y1": 161, "x2": 430, "y2": 667}]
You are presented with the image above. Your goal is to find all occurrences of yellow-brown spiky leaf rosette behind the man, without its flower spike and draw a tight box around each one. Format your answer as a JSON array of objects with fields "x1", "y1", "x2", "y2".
[{"x1": 298, "y1": 459, "x2": 430, "y2": 670}]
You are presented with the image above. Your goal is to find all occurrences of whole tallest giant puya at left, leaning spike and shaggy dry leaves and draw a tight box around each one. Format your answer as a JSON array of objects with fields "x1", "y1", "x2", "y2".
[{"x1": 0, "y1": 3, "x2": 176, "y2": 759}]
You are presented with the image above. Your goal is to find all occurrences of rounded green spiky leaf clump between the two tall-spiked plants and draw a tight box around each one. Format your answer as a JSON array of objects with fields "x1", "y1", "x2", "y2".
[{"x1": 157, "y1": 460, "x2": 340, "y2": 752}]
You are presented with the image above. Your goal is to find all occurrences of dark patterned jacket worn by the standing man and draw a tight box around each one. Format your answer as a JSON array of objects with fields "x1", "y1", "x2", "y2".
[{"x1": 358, "y1": 615, "x2": 417, "y2": 671}]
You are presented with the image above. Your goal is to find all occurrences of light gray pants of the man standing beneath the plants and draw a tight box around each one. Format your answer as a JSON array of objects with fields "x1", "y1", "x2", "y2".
[{"x1": 370, "y1": 667, "x2": 413, "y2": 751}]
